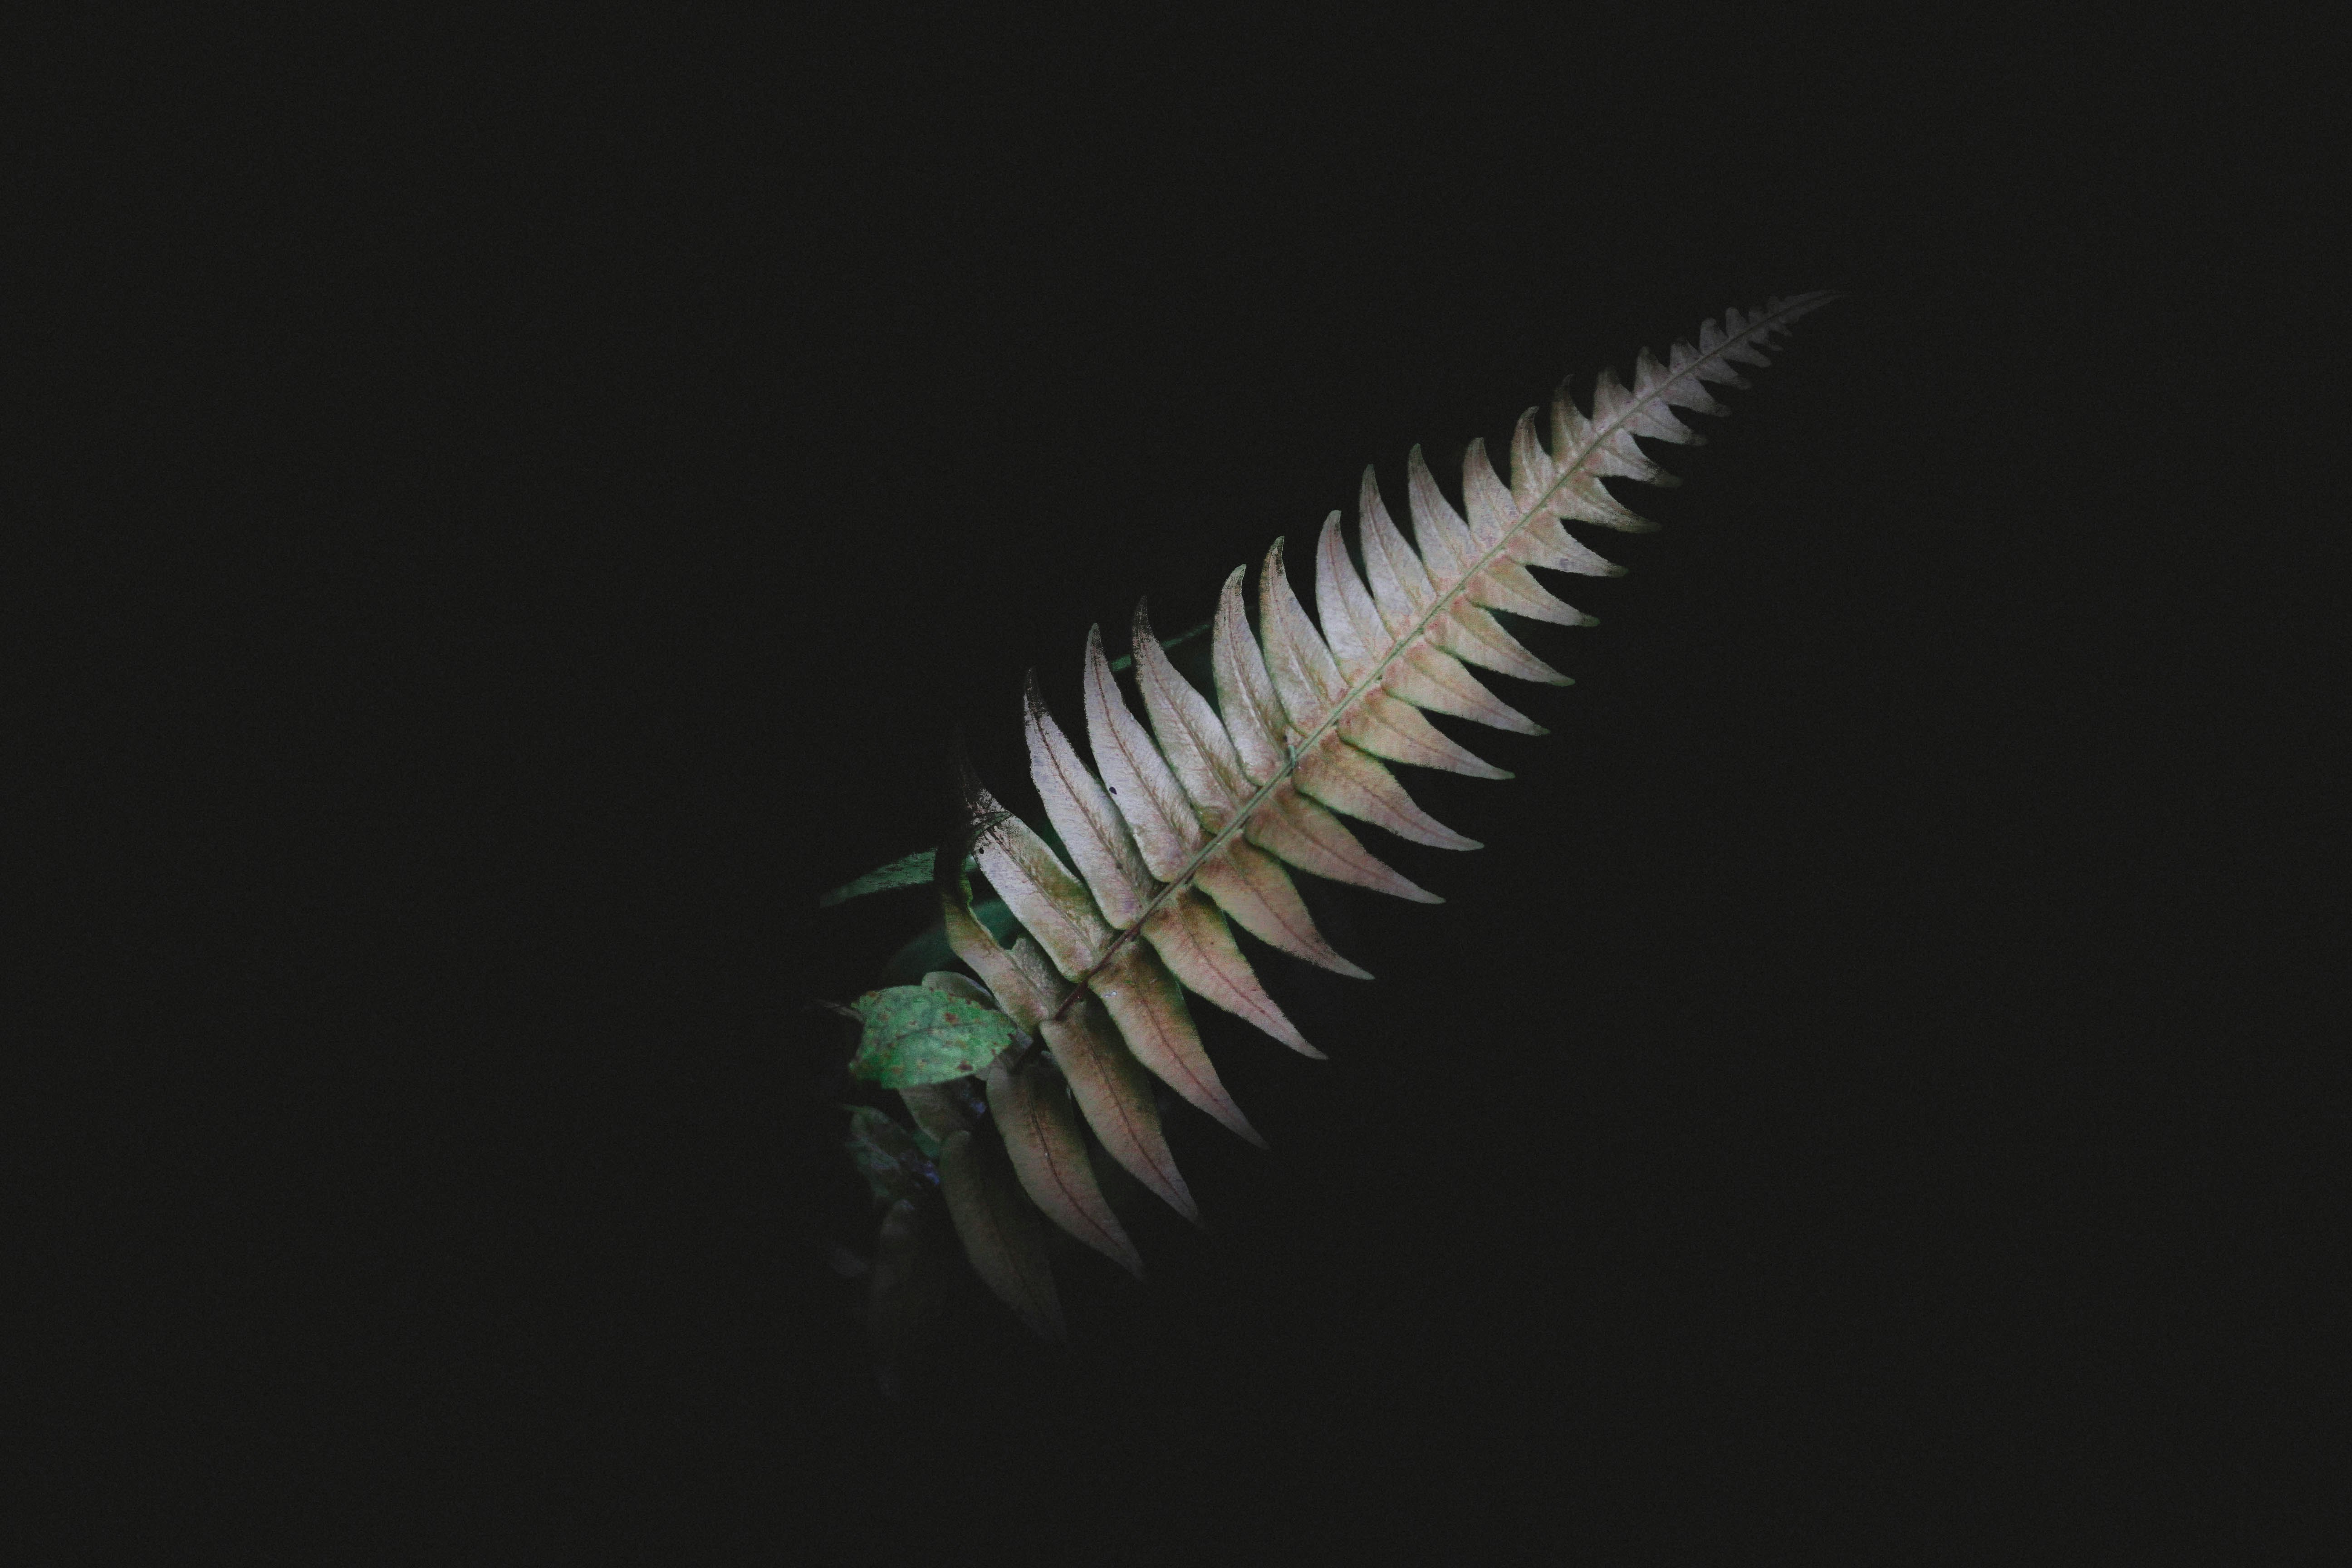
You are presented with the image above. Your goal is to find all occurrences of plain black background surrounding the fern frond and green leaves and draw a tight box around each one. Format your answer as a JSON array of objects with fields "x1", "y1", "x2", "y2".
[{"x1": 16, "y1": 7, "x2": 2342, "y2": 1561}]
